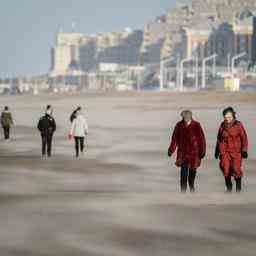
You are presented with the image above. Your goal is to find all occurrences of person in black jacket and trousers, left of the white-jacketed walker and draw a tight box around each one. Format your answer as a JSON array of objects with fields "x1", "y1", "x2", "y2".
[{"x1": 37, "y1": 105, "x2": 56, "y2": 157}]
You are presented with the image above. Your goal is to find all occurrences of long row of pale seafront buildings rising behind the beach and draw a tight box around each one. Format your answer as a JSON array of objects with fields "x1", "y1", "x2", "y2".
[{"x1": 48, "y1": 0, "x2": 256, "y2": 91}]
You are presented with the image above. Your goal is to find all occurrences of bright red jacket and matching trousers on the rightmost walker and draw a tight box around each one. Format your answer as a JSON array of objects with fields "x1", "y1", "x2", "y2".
[{"x1": 216, "y1": 120, "x2": 248, "y2": 178}]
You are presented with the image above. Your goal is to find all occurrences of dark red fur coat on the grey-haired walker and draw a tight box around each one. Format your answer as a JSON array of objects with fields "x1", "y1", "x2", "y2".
[{"x1": 169, "y1": 120, "x2": 206, "y2": 168}]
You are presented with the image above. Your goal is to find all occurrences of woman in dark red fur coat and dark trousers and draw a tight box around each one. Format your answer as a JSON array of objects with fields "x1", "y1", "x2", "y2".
[{"x1": 168, "y1": 110, "x2": 206, "y2": 192}]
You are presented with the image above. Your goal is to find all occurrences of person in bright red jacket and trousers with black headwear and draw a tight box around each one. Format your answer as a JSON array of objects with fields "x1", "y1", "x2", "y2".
[{"x1": 215, "y1": 107, "x2": 248, "y2": 192}]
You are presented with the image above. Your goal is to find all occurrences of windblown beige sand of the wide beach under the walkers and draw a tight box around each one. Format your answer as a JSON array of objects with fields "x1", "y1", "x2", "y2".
[{"x1": 0, "y1": 92, "x2": 256, "y2": 256}]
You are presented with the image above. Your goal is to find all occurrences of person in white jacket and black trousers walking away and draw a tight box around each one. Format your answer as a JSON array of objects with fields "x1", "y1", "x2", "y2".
[{"x1": 70, "y1": 110, "x2": 88, "y2": 157}]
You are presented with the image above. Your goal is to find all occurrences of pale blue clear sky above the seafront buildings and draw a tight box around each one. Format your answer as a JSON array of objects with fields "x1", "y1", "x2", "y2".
[{"x1": 0, "y1": 0, "x2": 177, "y2": 78}]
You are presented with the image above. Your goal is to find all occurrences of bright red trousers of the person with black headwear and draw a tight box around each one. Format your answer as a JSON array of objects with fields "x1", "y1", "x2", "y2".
[{"x1": 220, "y1": 152, "x2": 243, "y2": 178}]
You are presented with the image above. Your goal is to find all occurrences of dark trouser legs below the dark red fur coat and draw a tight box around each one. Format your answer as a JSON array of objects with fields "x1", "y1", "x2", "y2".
[{"x1": 180, "y1": 164, "x2": 196, "y2": 192}]
